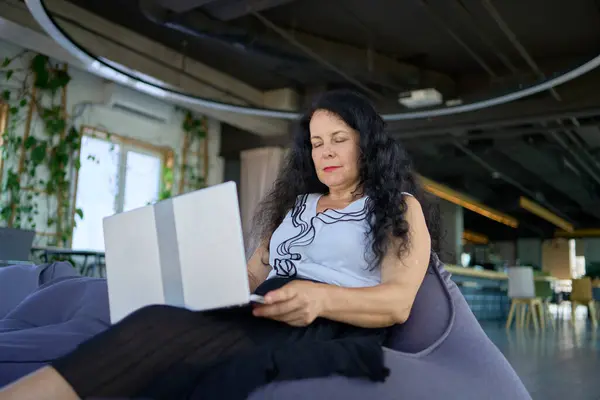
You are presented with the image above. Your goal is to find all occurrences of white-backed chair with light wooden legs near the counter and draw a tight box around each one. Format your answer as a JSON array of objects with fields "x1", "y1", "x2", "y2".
[{"x1": 506, "y1": 267, "x2": 544, "y2": 332}]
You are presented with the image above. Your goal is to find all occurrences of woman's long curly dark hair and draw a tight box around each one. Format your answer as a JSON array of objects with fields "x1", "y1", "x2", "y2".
[{"x1": 254, "y1": 90, "x2": 439, "y2": 268}]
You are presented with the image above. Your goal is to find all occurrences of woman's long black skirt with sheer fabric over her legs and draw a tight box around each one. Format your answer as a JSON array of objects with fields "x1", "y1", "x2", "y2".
[{"x1": 52, "y1": 278, "x2": 389, "y2": 400}]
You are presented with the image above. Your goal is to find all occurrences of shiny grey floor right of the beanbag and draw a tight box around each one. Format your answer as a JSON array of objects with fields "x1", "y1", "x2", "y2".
[{"x1": 482, "y1": 314, "x2": 600, "y2": 400}]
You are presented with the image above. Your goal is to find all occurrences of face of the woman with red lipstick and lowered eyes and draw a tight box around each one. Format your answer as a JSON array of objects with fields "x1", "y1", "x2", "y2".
[{"x1": 309, "y1": 110, "x2": 360, "y2": 190}]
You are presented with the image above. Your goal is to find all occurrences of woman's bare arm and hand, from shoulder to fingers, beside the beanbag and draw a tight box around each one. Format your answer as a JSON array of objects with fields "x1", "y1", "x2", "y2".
[{"x1": 255, "y1": 197, "x2": 431, "y2": 328}]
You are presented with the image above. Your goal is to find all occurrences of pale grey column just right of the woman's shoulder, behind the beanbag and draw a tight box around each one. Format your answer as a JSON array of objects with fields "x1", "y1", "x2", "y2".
[{"x1": 439, "y1": 200, "x2": 464, "y2": 265}]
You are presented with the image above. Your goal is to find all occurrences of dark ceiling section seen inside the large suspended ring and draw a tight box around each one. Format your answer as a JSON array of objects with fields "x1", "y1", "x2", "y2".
[{"x1": 64, "y1": 0, "x2": 600, "y2": 95}]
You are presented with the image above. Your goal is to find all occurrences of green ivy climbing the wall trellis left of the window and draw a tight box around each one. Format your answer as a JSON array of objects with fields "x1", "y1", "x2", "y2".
[{"x1": 0, "y1": 51, "x2": 83, "y2": 246}]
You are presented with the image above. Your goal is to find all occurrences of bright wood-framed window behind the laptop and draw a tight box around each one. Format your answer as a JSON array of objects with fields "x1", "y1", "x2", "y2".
[{"x1": 72, "y1": 128, "x2": 170, "y2": 251}]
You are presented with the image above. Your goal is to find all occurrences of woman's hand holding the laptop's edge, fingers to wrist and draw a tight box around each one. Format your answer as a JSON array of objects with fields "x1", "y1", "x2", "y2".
[{"x1": 254, "y1": 281, "x2": 325, "y2": 326}]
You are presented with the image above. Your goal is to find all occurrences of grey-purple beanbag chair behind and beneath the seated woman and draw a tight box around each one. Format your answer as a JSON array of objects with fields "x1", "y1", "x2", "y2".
[{"x1": 245, "y1": 257, "x2": 531, "y2": 400}]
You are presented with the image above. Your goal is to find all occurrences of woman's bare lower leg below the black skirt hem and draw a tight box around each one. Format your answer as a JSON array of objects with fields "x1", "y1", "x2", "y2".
[{"x1": 0, "y1": 367, "x2": 79, "y2": 400}]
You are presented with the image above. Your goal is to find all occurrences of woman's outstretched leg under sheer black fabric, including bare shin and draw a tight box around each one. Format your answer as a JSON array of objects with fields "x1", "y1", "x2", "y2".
[{"x1": 0, "y1": 306, "x2": 254, "y2": 400}]
